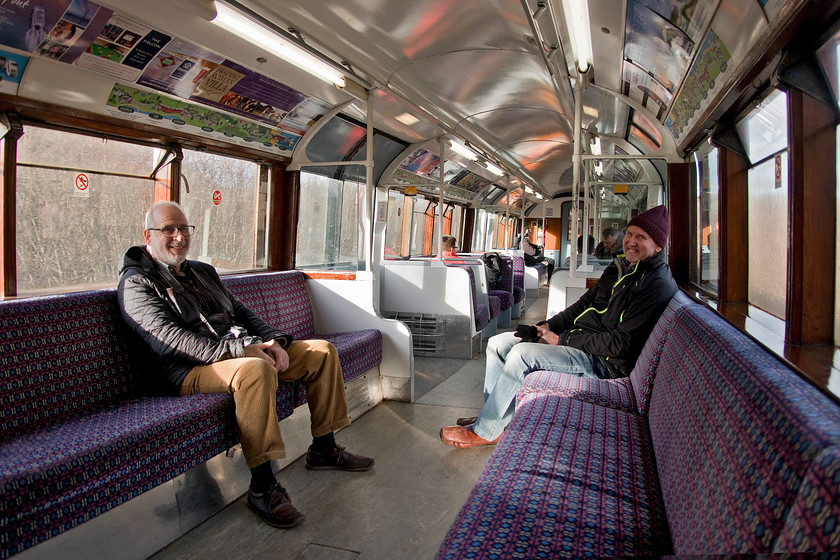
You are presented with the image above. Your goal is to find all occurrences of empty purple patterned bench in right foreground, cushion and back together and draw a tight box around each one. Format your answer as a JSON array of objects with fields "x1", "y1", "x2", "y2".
[{"x1": 437, "y1": 301, "x2": 840, "y2": 559}]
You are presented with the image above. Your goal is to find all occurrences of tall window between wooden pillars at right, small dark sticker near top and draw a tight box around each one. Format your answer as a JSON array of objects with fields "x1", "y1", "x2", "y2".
[{"x1": 737, "y1": 91, "x2": 788, "y2": 319}]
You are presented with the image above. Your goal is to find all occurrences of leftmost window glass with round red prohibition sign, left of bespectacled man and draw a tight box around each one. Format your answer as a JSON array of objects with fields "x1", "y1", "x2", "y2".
[{"x1": 16, "y1": 126, "x2": 161, "y2": 294}]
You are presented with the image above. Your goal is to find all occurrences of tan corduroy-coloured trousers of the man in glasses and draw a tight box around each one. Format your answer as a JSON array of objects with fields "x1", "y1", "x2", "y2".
[{"x1": 181, "y1": 340, "x2": 350, "y2": 468}]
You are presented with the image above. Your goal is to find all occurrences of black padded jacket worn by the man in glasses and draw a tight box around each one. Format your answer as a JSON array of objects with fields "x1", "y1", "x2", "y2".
[{"x1": 117, "y1": 246, "x2": 292, "y2": 394}]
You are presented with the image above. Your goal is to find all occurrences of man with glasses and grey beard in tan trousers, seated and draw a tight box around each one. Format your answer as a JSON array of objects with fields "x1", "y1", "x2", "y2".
[{"x1": 117, "y1": 202, "x2": 373, "y2": 527}]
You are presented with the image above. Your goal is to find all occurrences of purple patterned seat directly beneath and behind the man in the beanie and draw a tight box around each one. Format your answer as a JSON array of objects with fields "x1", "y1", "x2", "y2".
[{"x1": 516, "y1": 291, "x2": 699, "y2": 416}]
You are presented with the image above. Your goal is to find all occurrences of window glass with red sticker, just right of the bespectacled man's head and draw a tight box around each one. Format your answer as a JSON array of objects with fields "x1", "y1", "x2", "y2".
[{"x1": 181, "y1": 149, "x2": 268, "y2": 272}]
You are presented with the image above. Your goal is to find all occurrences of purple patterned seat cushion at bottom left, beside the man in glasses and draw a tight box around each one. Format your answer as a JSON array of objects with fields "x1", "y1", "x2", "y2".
[{"x1": 0, "y1": 394, "x2": 239, "y2": 554}]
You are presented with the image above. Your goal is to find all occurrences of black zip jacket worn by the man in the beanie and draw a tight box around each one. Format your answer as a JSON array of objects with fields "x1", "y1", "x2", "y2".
[{"x1": 548, "y1": 251, "x2": 678, "y2": 377}]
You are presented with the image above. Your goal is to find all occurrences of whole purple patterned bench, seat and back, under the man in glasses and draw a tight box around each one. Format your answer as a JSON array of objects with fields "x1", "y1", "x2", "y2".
[{"x1": 0, "y1": 272, "x2": 382, "y2": 559}]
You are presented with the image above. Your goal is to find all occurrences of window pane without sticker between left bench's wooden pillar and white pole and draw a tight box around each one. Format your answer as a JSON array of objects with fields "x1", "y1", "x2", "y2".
[{"x1": 295, "y1": 171, "x2": 365, "y2": 270}]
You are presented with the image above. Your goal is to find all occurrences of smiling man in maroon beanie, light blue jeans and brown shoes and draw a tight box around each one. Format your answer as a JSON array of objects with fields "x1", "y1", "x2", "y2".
[{"x1": 440, "y1": 206, "x2": 677, "y2": 447}]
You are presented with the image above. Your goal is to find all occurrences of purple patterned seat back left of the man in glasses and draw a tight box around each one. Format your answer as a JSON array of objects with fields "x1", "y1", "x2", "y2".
[{"x1": 0, "y1": 289, "x2": 142, "y2": 441}]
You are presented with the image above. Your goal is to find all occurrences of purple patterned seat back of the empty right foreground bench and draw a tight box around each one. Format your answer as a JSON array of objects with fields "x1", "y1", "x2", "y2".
[{"x1": 648, "y1": 305, "x2": 840, "y2": 555}]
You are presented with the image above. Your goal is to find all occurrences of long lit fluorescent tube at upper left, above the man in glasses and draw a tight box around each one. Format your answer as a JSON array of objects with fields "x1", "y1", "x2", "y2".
[{"x1": 212, "y1": 2, "x2": 345, "y2": 88}]
